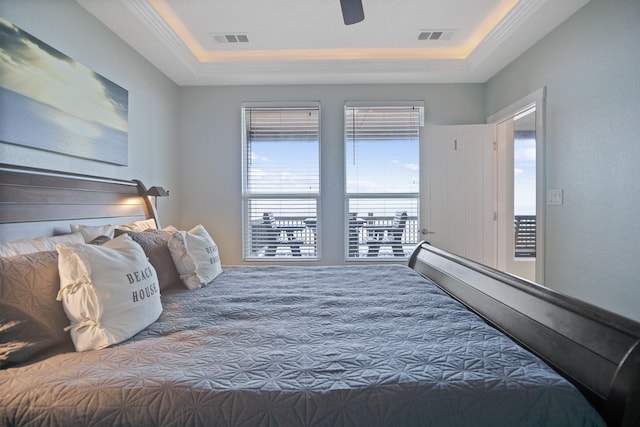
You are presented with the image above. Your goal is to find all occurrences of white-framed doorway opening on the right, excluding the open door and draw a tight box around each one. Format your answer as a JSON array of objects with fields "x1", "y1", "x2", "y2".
[{"x1": 488, "y1": 88, "x2": 545, "y2": 283}]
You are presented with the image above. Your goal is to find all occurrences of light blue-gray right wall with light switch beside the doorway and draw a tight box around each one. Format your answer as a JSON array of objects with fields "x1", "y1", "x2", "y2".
[{"x1": 485, "y1": 0, "x2": 640, "y2": 320}]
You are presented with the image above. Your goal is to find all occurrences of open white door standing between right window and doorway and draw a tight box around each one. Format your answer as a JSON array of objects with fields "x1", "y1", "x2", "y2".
[{"x1": 420, "y1": 125, "x2": 496, "y2": 266}]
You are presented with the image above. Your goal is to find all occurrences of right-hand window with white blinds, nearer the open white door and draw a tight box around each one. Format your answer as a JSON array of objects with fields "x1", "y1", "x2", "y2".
[{"x1": 344, "y1": 102, "x2": 424, "y2": 260}]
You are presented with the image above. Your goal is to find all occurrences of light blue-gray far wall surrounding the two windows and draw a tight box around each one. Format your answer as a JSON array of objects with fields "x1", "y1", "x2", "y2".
[{"x1": 178, "y1": 84, "x2": 484, "y2": 264}]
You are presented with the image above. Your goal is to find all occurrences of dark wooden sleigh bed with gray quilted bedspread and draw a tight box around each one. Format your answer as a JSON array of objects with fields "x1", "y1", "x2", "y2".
[{"x1": 0, "y1": 165, "x2": 640, "y2": 426}]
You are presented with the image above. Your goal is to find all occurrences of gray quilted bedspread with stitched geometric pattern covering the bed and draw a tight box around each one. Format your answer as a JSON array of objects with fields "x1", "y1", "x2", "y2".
[{"x1": 0, "y1": 265, "x2": 602, "y2": 426}]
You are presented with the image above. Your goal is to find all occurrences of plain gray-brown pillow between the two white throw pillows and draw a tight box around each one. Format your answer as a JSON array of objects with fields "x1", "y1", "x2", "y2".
[{"x1": 115, "y1": 229, "x2": 180, "y2": 290}]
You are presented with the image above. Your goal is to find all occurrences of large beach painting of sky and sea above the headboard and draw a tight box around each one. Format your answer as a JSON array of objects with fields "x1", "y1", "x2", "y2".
[{"x1": 0, "y1": 18, "x2": 129, "y2": 165}]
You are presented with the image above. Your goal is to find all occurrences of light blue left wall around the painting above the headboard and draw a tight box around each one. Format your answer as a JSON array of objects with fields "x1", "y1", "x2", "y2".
[{"x1": 0, "y1": 0, "x2": 179, "y2": 227}]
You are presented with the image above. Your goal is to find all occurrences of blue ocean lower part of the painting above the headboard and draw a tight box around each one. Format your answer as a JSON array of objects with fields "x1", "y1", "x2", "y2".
[{"x1": 0, "y1": 86, "x2": 128, "y2": 165}]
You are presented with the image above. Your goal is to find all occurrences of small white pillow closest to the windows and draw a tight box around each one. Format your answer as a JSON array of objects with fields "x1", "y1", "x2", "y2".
[{"x1": 168, "y1": 225, "x2": 222, "y2": 289}]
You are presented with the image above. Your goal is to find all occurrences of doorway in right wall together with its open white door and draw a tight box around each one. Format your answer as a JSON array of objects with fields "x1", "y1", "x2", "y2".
[{"x1": 420, "y1": 88, "x2": 546, "y2": 284}]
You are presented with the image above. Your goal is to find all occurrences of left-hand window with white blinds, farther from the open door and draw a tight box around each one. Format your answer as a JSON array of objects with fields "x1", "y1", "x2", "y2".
[{"x1": 242, "y1": 103, "x2": 321, "y2": 261}]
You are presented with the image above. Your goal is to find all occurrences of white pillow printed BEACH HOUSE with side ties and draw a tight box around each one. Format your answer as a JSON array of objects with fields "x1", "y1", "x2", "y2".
[{"x1": 56, "y1": 234, "x2": 162, "y2": 351}]
